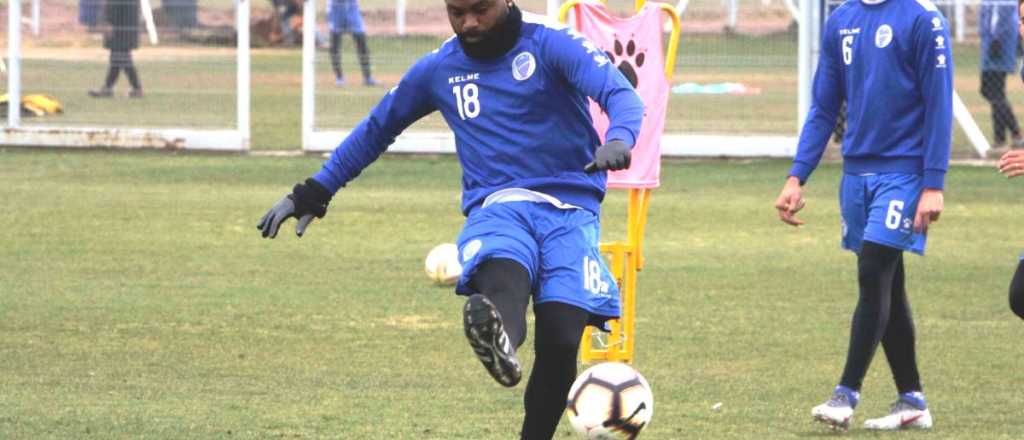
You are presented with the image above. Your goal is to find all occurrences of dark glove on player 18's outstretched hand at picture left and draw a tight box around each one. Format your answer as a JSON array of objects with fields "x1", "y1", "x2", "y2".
[{"x1": 256, "y1": 178, "x2": 331, "y2": 238}]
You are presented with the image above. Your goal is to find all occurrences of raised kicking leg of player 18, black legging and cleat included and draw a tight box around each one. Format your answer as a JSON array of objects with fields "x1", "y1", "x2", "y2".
[{"x1": 463, "y1": 258, "x2": 530, "y2": 387}]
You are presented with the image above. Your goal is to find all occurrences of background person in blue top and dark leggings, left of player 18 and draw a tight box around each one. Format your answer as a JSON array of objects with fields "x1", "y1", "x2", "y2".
[{"x1": 327, "y1": 0, "x2": 379, "y2": 86}]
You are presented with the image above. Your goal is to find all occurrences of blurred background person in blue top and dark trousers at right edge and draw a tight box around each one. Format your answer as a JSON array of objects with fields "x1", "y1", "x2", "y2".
[{"x1": 978, "y1": 0, "x2": 1024, "y2": 156}]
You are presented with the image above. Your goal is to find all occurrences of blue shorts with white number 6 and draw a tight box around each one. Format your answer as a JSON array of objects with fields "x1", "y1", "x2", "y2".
[{"x1": 839, "y1": 174, "x2": 927, "y2": 255}]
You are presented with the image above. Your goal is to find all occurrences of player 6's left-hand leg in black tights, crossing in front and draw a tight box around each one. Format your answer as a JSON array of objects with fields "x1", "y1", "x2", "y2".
[{"x1": 840, "y1": 241, "x2": 903, "y2": 390}]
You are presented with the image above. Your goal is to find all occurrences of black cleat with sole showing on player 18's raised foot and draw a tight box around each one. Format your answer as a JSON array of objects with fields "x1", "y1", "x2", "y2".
[{"x1": 462, "y1": 294, "x2": 522, "y2": 387}]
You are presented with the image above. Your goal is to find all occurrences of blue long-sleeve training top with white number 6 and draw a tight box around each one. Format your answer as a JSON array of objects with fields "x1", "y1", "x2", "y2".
[{"x1": 790, "y1": 0, "x2": 953, "y2": 189}]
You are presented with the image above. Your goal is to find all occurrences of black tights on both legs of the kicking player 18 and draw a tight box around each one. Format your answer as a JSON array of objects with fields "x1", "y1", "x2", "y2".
[{"x1": 469, "y1": 258, "x2": 590, "y2": 440}]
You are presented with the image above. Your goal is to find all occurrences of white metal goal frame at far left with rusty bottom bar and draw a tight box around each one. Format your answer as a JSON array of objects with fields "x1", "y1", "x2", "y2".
[{"x1": 0, "y1": 0, "x2": 252, "y2": 151}]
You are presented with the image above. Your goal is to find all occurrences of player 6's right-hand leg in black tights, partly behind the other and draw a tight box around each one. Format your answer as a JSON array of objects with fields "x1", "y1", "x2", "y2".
[{"x1": 882, "y1": 254, "x2": 922, "y2": 394}]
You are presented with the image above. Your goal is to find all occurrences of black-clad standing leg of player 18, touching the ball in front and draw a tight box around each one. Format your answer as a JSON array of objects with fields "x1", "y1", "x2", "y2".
[{"x1": 521, "y1": 303, "x2": 590, "y2": 440}]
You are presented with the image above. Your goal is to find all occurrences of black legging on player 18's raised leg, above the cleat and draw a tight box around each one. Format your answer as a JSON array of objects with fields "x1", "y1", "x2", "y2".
[{"x1": 469, "y1": 258, "x2": 531, "y2": 348}]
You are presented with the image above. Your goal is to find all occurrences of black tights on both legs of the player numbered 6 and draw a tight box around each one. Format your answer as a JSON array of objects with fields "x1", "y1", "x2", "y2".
[{"x1": 840, "y1": 241, "x2": 922, "y2": 393}]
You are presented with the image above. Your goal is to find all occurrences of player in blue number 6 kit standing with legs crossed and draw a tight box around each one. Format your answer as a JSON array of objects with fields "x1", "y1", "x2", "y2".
[{"x1": 775, "y1": 0, "x2": 953, "y2": 430}]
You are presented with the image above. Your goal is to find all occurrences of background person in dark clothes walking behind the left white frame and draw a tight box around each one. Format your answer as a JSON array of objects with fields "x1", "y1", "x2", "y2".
[{"x1": 89, "y1": 0, "x2": 142, "y2": 98}]
